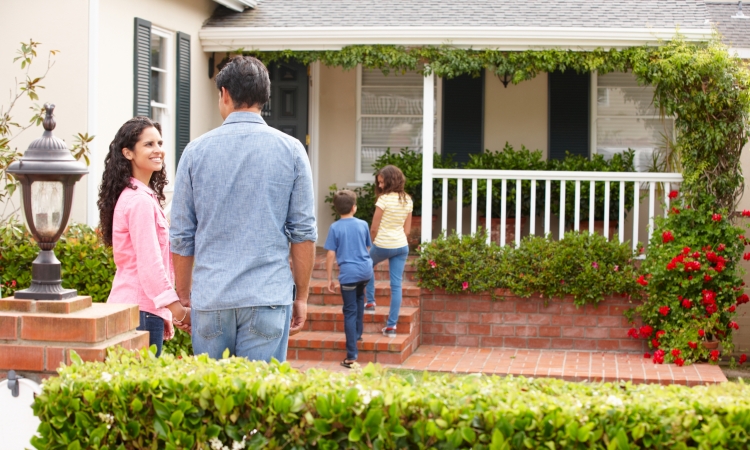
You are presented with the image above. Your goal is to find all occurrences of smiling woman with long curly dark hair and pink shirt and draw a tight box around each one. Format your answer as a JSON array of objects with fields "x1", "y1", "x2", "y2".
[{"x1": 97, "y1": 117, "x2": 190, "y2": 356}]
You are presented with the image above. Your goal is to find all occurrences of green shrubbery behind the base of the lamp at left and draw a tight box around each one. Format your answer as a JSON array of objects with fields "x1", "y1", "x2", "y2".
[{"x1": 0, "y1": 219, "x2": 116, "y2": 302}]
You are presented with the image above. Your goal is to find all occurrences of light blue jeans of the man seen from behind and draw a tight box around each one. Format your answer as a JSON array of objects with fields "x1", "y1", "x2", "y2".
[{"x1": 190, "y1": 305, "x2": 292, "y2": 362}]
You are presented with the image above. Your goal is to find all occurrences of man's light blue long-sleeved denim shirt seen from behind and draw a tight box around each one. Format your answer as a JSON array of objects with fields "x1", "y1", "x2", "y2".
[{"x1": 169, "y1": 112, "x2": 317, "y2": 311}]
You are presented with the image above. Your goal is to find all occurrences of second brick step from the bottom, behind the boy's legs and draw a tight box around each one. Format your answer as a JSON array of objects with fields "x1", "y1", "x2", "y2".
[{"x1": 305, "y1": 305, "x2": 419, "y2": 334}]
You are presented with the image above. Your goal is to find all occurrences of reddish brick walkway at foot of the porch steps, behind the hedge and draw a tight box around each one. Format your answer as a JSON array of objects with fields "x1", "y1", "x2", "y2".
[{"x1": 289, "y1": 345, "x2": 727, "y2": 386}]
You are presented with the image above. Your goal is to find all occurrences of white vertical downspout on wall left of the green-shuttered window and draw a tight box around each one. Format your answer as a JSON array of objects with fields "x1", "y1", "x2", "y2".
[{"x1": 86, "y1": 0, "x2": 100, "y2": 227}]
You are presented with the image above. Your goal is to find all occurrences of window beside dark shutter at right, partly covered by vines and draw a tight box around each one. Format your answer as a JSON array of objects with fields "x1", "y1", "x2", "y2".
[{"x1": 592, "y1": 72, "x2": 674, "y2": 172}]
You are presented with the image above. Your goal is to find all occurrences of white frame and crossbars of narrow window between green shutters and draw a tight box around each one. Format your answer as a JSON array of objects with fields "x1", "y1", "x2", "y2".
[{"x1": 149, "y1": 24, "x2": 177, "y2": 186}]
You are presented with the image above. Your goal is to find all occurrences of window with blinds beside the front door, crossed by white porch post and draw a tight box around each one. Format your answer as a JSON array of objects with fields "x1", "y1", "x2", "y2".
[{"x1": 357, "y1": 66, "x2": 440, "y2": 181}]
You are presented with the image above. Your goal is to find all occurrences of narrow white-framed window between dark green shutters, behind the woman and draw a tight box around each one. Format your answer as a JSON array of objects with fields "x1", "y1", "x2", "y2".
[{"x1": 151, "y1": 26, "x2": 175, "y2": 180}]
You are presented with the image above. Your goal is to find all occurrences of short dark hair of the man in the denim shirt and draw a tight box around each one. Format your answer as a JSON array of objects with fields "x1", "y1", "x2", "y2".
[{"x1": 216, "y1": 56, "x2": 271, "y2": 109}]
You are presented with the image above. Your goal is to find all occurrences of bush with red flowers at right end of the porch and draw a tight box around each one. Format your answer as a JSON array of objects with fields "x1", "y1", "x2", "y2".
[{"x1": 636, "y1": 195, "x2": 750, "y2": 364}]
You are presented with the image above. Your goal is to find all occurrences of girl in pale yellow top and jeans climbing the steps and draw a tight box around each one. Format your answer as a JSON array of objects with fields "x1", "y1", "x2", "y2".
[{"x1": 365, "y1": 166, "x2": 413, "y2": 337}]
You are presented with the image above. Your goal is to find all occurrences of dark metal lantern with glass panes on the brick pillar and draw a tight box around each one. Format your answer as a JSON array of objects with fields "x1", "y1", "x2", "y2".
[{"x1": 8, "y1": 103, "x2": 88, "y2": 300}]
